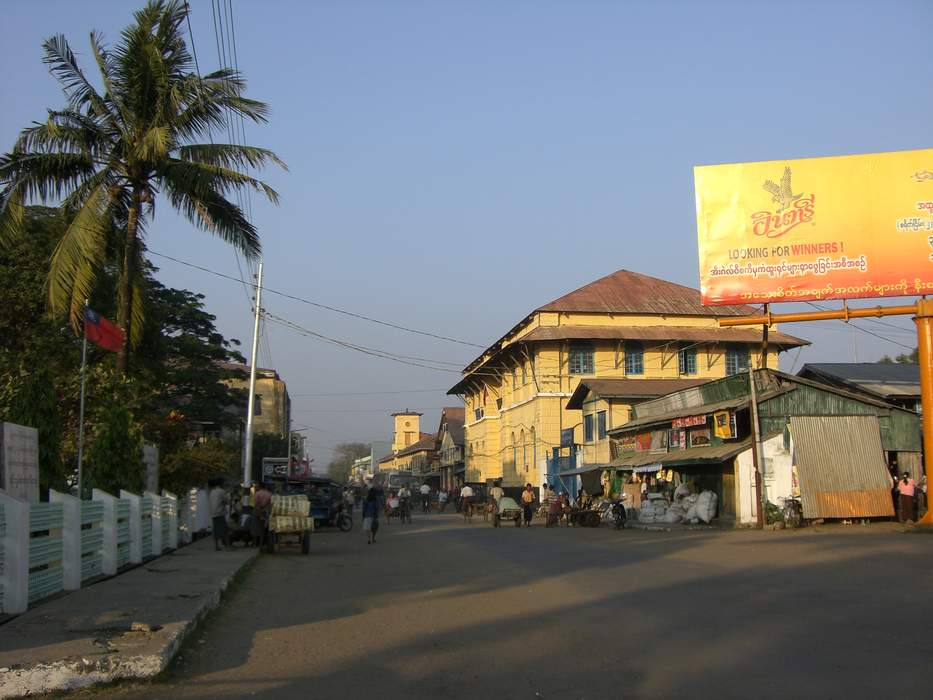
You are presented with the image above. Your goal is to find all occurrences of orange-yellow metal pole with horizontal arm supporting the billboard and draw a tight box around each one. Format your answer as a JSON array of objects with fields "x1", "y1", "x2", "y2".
[{"x1": 719, "y1": 298, "x2": 933, "y2": 525}]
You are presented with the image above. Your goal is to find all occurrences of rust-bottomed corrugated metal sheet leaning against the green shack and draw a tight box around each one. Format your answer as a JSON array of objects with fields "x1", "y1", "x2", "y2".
[{"x1": 790, "y1": 416, "x2": 894, "y2": 518}]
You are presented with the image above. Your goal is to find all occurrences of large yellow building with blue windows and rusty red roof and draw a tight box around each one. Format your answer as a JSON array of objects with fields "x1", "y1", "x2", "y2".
[{"x1": 448, "y1": 270, "x2": 805, "y2": 486}]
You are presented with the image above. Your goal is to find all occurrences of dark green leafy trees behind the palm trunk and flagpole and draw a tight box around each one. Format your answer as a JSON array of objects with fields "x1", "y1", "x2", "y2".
[{"x1": 0, "y1": 207, "x2": 248, "y2": 489}]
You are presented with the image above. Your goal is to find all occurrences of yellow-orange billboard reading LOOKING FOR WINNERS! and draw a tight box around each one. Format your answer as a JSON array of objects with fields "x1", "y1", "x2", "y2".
[{"x1": 694, "y1": 149, "x2": 933, "y2": 305}]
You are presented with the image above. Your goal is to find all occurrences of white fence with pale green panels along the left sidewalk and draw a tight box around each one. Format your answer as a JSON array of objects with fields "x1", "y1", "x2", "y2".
[{"x1": 0, "y1": 489, "x2": 210, "y2": 613}]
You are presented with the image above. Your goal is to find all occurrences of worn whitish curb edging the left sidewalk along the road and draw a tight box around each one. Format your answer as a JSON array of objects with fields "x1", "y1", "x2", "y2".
[{"x1": 0, "y1": 550, "x2": 259, "y2": 698}]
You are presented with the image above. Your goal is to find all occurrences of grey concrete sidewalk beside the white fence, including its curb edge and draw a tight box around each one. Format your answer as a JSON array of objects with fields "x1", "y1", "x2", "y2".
[{"x1": 0, "y1": 539, "x2": 258, "y2": 698}]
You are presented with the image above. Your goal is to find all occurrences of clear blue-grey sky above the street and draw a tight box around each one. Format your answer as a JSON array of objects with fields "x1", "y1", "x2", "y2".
[{"x1": 0, "y1": 0, "x2": 933, "y2": 464}]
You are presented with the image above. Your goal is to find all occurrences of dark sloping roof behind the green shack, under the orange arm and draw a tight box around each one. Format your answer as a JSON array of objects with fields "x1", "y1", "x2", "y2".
[{"x1": 797, "y1": 362, "x2": 922, "y2": 413}]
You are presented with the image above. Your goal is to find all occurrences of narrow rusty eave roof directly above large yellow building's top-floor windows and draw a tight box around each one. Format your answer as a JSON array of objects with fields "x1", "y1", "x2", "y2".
[{"x1": 521, "y1": 325, "x2": 810, "y2": 348}]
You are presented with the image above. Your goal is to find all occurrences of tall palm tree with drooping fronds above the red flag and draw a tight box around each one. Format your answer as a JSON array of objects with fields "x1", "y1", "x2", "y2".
[{"x1": 0, "y1": 0, "x2": 285, "y2": 373}]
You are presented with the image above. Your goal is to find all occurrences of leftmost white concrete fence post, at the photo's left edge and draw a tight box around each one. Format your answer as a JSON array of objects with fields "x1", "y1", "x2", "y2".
[{"x1": 0, "y1": 493, "x2": 29, "y2": 614}]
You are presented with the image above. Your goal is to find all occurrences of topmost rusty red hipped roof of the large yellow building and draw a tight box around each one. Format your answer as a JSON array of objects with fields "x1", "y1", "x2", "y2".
[{"x1": 537, "y1": 270, "x2": 757, "y2": 316}]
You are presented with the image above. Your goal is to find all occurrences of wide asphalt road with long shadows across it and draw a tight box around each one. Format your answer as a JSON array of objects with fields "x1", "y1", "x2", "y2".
[{"x1": 88, "y1": 515, "x2": 933, "y2": 700}]
